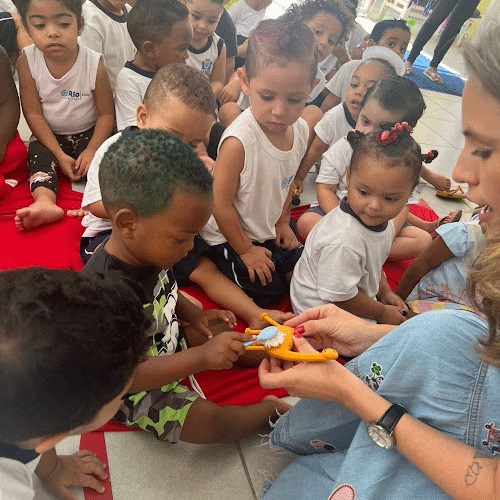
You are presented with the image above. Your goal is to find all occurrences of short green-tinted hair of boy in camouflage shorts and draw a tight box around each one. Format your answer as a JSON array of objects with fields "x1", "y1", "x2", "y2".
[{"x1": 99, "y1": 129, "x2": 212, "y2": 218}]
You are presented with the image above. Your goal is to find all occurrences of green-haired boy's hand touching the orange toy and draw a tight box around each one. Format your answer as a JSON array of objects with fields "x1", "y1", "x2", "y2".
[{"x1": 201, "y1": 332, "x2": 246, "y2": 370}]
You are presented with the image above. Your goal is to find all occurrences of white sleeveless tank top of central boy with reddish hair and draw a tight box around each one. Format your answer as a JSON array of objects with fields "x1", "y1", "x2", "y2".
[{"x1": 201, "y1": 108, "x2": 309, "y2": 246}]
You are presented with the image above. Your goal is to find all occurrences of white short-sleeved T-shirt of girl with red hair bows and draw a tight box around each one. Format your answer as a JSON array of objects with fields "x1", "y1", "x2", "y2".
[{"x1": 290, "y1": 199, "x2": 394, "y2": 314}]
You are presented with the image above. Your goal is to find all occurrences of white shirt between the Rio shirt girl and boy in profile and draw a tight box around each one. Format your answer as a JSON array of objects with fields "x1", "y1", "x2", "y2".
[{"x1": 80, "y1": 0, "x2": 135, "y2": 91}]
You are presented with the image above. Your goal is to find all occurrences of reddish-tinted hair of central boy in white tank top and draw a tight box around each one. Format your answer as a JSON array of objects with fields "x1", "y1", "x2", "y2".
[{"x1": 245, "y1": 14, "x2": 317, "y2": 82}]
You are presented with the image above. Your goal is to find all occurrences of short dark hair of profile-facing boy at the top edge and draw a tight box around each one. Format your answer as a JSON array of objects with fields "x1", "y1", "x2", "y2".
[{"x1": 127, "y1": 0, "x2": 189, "y2": 51}]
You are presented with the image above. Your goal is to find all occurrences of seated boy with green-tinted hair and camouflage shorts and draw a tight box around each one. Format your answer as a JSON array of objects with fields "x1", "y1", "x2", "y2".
[{"x1": 84, "y1": 130, "x2": 288, "y2": 443}]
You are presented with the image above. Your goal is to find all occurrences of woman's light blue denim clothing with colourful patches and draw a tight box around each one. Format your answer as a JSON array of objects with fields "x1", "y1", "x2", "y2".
[{"x1": 263, "y1": 310, "x2": 500, "y2": 500}]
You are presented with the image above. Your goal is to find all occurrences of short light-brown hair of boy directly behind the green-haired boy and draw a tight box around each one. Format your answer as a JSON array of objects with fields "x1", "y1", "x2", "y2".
[{"x1": 144, "y1": 63, "x2": 215, "y2": 115}]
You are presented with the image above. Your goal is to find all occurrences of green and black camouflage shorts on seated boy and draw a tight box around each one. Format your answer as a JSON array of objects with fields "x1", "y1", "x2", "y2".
[{"x1": 115, "y1": 382, "x2": 200, "y2": 443}]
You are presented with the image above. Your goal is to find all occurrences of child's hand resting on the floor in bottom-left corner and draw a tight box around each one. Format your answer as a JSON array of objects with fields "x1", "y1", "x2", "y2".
[{"x1": 36, "y1": 450, "x2": 108, "y2": 500}]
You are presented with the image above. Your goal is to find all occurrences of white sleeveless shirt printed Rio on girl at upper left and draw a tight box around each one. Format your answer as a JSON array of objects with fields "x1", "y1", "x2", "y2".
[{"x1": 24, "y1": 44, "x2": 102, "y2": 135}]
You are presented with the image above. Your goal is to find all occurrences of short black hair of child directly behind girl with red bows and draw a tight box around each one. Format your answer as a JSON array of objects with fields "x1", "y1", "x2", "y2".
[{"x1": 361, "y1": 75, "x2": 425, "y2": 127}]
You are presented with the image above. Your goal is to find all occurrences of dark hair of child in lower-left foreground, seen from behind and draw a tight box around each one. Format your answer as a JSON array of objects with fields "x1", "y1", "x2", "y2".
[{"x1": 0, "y1": 267, "x2": 148, "y2": 444}]
